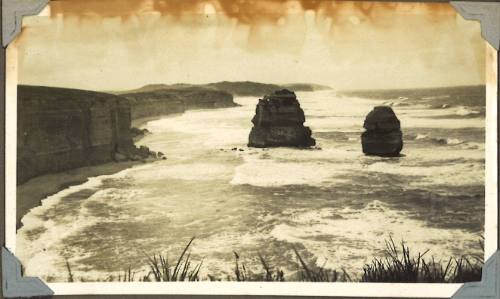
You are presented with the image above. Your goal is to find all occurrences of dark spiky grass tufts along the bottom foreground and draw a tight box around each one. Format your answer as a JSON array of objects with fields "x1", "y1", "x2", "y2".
[{"x1": 66, "y1": 238, "x2": 484, "y2": 283}]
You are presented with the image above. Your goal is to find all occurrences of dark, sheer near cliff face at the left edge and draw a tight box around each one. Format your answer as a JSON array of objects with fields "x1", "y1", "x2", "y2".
[{"x1": 17, "y1": 86, "x2": 135, "y2": 184}]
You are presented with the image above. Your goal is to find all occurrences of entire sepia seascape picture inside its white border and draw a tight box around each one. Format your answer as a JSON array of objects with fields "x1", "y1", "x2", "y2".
[{"x1": 7, "y1": 0, "x2": 497, "y2": 290}]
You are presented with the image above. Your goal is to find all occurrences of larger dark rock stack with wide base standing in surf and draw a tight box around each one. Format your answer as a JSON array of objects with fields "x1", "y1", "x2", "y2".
[{"x1": 248, "y1": 89, "x2": 316, "y2": 147}]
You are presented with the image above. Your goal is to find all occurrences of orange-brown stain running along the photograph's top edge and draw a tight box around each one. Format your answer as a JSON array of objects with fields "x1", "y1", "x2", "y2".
[{"x1": 50, "y1": 0, "x2": 456, "y2": 24}]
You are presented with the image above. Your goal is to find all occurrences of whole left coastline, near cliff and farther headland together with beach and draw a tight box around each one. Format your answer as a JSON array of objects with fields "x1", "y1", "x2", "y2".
[{"x1": 16, "y1": 85, "x2": 237, "y2": 228}]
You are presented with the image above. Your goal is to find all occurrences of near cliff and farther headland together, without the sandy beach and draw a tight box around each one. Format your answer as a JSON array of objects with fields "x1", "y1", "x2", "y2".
[{"x1": 17, "y1": 85, "x2": 237, "y2": 185}]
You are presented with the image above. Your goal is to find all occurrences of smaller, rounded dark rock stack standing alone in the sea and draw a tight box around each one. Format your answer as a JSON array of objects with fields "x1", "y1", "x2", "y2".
[{"x1": 361, "y1": 106, "x2": 403, "y2": 157}]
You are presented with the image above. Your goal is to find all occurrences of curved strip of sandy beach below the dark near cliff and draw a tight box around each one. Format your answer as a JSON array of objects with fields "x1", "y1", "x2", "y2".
[{"x1": 16, "y1": 161, "x2": 143, "y2": 229}]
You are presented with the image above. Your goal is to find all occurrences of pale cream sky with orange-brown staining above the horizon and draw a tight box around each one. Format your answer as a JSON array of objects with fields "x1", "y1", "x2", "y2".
[{"x1": 11, "y1": 0, "x2": 485, "y2": 90}]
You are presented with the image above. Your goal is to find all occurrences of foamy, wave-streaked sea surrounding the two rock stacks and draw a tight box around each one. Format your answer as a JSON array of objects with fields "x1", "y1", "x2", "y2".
[{"x1": 16, "y1": 91, "x2": 485, "y2": 281}]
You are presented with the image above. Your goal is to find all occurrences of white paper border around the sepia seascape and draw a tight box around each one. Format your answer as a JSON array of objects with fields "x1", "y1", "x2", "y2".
[{"x1": 1, "y1": 1, "x2": 499, "y2": 298}]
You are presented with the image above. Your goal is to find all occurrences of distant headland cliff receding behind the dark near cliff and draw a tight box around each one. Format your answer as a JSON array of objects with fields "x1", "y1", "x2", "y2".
[{"x1": 121, "y1": 87, "x2": 236, "y2": 119}]
